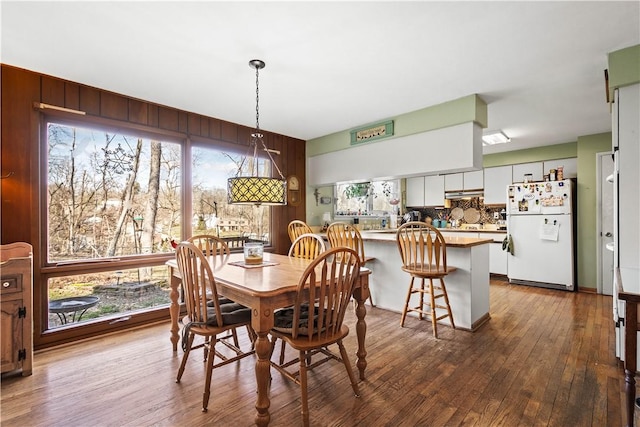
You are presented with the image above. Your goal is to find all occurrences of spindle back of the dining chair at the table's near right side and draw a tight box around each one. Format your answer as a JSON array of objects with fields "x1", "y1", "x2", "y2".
[{"x1": 291, "y1": 247, "x2": 360, "y2": 342}]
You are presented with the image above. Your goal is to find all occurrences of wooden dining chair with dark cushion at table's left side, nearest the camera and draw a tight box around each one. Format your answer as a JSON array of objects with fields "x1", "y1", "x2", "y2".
[{"x1": 176, "y1": 242, "x2": 255, "y2": 412}]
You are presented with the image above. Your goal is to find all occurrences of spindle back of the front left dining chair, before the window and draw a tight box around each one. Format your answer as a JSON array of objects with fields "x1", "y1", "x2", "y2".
[{"x1": 176, "y1": 242, "x2": 223, "y2": 325}]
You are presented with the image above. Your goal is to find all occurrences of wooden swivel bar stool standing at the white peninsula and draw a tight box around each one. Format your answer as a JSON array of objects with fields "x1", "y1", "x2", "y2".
[{"x1": 396, "y1": 221, "x2": 456, "y2": 338}]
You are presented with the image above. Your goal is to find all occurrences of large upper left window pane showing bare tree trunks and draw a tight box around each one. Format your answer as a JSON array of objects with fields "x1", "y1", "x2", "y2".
[{"x1": 47, "y1": 123, "x2": 181, "y2": 262}]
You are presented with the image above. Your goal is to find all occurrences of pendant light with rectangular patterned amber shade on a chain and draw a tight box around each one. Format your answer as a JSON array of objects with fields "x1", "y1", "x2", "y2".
[{"x1": 227, "y1": 59, "x2": 287, "y2": 206}]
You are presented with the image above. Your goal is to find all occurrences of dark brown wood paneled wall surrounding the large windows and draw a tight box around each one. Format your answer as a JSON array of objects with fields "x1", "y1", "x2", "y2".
[{"x1": 0, "y1": 64, "x2": 306, "y2": 258}]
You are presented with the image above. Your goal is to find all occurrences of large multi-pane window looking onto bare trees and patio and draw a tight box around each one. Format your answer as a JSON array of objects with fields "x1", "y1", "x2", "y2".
[{"x1": 42, "y1": 120, "x2": 271, "y2": 330}]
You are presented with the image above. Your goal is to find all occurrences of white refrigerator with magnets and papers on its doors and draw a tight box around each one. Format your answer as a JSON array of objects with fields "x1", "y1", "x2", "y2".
[{"x1": 507, "y1": 179, "x2": 575, "y2": 291}]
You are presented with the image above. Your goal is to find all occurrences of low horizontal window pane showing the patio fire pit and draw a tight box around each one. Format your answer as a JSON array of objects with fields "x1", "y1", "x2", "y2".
[{"x1": 48, "y1": 265, "x2": 170, "y2": 329}]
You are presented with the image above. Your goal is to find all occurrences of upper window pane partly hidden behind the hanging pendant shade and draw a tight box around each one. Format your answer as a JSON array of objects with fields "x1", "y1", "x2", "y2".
[{"x1": 191, "y1": 147, "x2": 271, "y2": 247}]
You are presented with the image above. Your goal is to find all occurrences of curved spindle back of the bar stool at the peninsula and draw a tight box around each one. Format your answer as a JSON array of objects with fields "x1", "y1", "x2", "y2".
[{"x1": 396, "y1": 221, "x2": 448, "y2": 276}]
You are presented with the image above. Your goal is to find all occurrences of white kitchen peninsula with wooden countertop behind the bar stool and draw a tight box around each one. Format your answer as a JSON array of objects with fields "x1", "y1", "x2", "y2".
[{"x1": 361, "y1": 230, "x2": 493, "y2": 331}]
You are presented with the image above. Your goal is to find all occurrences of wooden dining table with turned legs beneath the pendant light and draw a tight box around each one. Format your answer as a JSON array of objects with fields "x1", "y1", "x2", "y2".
[{"x1": 166, "y1": 253, "x2": 371, "y2": 426}]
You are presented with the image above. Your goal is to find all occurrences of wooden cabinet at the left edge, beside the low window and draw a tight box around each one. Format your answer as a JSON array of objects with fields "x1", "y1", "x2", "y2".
[{"x1": 0, "y1": 243, "x2": 33, "y2": 376}]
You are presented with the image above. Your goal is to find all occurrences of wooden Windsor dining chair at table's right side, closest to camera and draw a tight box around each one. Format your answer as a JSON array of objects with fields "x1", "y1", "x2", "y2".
[{"x1": 271, "y1": 247, "x2": 360, "y2": 426}]
